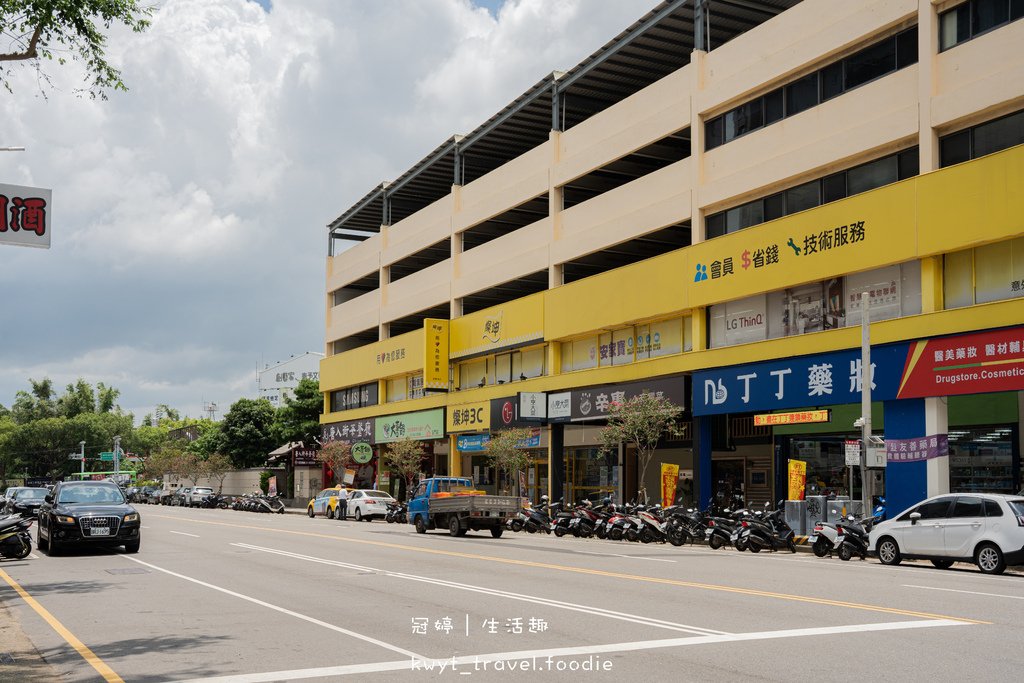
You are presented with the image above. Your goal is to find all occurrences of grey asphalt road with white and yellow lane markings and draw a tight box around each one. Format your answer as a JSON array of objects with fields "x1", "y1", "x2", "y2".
[{"x1": 0, "y1": 506, "x2": 1024, "y2": 683}]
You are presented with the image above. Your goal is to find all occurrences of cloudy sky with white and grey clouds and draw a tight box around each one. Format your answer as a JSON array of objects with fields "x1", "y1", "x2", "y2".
[{"x1": 0, "y1": 0, "x2": 656, "y2": 422}]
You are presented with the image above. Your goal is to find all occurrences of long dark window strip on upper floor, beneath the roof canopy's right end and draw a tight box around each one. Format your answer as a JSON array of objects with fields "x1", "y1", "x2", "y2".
[{"x1": 705, "y1": 28, "x2": 921, "y2": 151}]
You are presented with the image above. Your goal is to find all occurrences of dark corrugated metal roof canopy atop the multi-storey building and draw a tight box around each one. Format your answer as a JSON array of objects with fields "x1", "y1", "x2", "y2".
[{"x1": 328, "y1": 0, "x2": 800, "y2": 242}]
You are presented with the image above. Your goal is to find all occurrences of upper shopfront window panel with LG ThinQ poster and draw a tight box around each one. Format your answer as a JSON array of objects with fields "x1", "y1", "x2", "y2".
[{"x1": 709, "y1": 261, "x2": 921, "y2": 348}]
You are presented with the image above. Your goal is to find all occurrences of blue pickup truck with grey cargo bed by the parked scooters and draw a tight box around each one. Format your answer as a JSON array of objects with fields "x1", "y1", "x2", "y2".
[{"x1": 409, "y1": 477, "x2": 521, "y2": 539}]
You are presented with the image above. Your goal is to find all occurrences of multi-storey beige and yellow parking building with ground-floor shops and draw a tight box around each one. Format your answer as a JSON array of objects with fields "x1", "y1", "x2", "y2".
[{"x1": 321, "y1": 0, "x2": 1024, "y2": 516}]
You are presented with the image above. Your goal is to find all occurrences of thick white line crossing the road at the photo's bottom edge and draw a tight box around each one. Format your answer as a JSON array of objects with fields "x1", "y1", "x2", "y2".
[{"x1": 172, "y1": 620, "x2": 972, "y2": 683}]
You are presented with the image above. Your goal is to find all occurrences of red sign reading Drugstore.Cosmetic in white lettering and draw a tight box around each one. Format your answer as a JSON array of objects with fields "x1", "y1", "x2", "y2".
[{"x1": 898, "y1": 327, "x2": 1024, "y2": 398}]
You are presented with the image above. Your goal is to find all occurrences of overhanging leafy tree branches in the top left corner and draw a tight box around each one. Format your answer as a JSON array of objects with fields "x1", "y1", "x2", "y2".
[{"x1": 0, "y1": 0, "x2": 154, "y2": 99}]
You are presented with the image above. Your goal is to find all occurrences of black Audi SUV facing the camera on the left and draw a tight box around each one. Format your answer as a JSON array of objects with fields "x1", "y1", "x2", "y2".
[{"x1": 36, "y1": 481, "x2": 142, "y2": 556}]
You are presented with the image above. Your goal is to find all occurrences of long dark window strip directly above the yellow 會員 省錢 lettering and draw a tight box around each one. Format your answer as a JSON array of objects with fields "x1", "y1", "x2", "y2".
[{"x1": 705, "y1": 146, "x2": 920, "y2": 240}]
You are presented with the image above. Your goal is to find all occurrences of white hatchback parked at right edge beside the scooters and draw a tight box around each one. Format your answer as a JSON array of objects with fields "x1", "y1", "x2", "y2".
[{"x1": 868, "y1": 494, "x2": 1024, "y2": 573}]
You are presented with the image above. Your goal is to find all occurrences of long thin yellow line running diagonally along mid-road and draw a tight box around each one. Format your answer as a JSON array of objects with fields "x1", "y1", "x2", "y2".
[{"x1": 152, "y1": 515, "x2": 990, "y2": 624}]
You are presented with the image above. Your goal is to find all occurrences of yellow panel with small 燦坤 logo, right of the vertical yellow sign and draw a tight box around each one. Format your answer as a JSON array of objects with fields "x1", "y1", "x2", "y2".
[{"x1": 450, "y1": 292, "x2": 545, "y2": 358}]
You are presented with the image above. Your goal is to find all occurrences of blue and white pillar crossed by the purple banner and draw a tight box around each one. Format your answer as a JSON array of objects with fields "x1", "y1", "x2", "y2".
[{"x1": 884, "y1": 397, "x2": 949, "y2": 517}]
